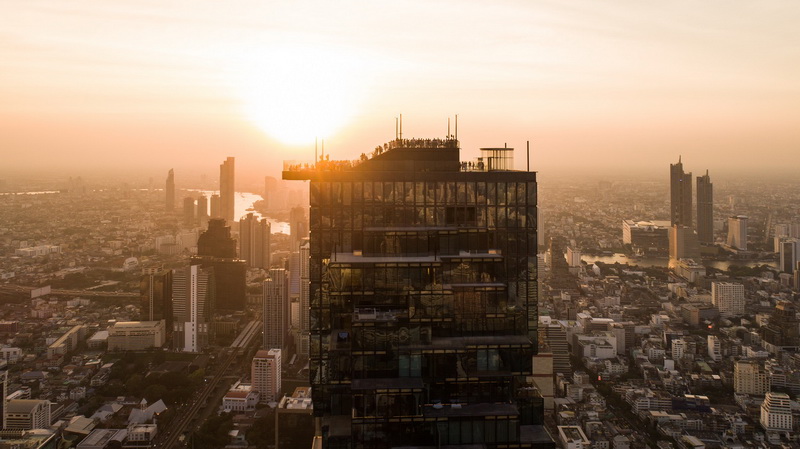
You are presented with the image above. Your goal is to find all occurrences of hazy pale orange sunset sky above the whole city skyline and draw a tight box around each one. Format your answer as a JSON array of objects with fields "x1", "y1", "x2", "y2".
[{"x1": 0, "y1": 0, "x2": 800, "y2": 179}]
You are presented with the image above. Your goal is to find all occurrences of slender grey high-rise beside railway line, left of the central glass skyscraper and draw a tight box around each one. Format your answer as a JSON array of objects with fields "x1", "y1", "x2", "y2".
[{"x1": 262, "y1": 268, "x2": 290, "y2": 349}]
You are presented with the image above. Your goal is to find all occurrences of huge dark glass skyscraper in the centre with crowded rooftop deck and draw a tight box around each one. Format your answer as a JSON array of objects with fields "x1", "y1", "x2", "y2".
[{"x1": 283, "y1": 138, "x2": 552, "y2": 448}]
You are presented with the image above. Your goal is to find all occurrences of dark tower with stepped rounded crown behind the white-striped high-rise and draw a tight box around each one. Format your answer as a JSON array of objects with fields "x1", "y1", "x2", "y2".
[{"x1": 191, "y1": 218, "x2": 247, "y2": 312}]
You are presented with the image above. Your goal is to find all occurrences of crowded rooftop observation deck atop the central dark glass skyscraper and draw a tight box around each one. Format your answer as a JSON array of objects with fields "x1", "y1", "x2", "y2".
[{"x1": 283, "y1": 138, "x2": 514, "y2": 180}]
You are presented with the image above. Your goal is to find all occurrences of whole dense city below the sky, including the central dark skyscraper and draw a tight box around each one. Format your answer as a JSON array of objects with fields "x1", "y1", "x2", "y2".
[{"x1": 0, "y1": 136, "x2": 800, "y2": 449}]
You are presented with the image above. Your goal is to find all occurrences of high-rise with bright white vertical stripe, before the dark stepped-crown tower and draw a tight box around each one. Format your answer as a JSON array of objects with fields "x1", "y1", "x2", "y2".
[{"x1": 172, "y1": 265, "x2": 215, "y2": 352}]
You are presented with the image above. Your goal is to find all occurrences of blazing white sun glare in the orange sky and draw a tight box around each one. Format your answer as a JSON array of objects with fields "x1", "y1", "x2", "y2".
[{"x1": 231, "y1": 46, "x2": 367, "y2": 145}]
